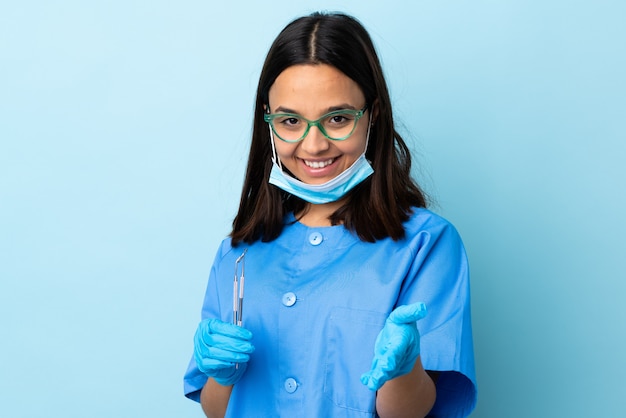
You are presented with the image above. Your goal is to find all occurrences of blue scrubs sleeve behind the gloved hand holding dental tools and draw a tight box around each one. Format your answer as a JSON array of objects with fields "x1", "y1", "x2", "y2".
[{"x1": 183, "y1": 241, "x2": 230, "y2": 402}]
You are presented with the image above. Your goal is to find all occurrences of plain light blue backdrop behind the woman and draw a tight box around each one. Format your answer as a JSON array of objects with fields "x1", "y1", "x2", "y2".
[{"x1": 0, "y1": 0, "x2": 626, "y2": 418}]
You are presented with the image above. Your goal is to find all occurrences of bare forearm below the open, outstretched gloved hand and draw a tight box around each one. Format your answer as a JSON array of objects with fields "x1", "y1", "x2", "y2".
[{"x1": 376, "y1": 357, "x2": 436, "y2": 418}]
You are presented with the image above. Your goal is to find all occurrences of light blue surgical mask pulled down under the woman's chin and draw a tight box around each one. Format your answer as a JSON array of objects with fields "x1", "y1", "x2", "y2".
[{"x1": 269, "y1": 116, "x2": 374, "y2": 204}]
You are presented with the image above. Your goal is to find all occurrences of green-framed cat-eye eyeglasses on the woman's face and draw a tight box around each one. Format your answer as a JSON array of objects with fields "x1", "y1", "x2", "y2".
[{"x1": 263, "y1": 103, "x2": 367, "y2": 142}]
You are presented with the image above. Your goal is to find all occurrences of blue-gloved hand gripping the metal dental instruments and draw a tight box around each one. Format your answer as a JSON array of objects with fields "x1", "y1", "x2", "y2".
[{"x1": 193, "y1": 319, "x2": 254, "y2": 386}]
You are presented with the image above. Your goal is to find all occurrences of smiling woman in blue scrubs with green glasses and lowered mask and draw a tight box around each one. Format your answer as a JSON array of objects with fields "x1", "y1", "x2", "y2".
[{"x1": 185, "y1": 13, "x2": 476, "y2": 417}]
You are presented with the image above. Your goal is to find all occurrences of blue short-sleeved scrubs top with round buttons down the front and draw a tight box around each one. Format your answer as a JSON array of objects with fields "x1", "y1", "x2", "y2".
[{"x1": 184, "y1": 209, "x2": 476, "y2": 418}]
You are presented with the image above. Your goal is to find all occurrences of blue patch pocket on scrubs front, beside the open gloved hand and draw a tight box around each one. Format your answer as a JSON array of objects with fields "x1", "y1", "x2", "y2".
[{"x1": 324, "y1": 308, "x2": 386, "y2": 416}]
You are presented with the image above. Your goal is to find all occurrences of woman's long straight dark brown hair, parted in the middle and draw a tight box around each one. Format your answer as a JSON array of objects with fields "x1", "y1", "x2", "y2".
[{"x1": 230, "y1": 13, "x2": 426, "y2": 246}]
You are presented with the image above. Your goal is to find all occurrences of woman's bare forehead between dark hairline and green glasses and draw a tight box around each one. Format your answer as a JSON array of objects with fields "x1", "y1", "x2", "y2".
[{"x1": 269, "y1": 64, "x2": 365, "y2": 113}]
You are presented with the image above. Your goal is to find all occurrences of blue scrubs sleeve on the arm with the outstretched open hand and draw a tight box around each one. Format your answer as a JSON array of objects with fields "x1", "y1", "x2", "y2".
[{"x1": 400, "y1": 215, "x2": 477, "y2": 417}]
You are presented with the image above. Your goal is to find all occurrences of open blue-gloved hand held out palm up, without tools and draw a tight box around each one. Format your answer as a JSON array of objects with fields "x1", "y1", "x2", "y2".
[{"x1": 361, "y1": 302, "x2": 426, "y2": 390}]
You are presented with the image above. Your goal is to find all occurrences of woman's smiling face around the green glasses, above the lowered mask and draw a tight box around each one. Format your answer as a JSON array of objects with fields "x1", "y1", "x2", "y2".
[{"x1": 269, "y1": 64, "x2": 369, "y2": 184}]
